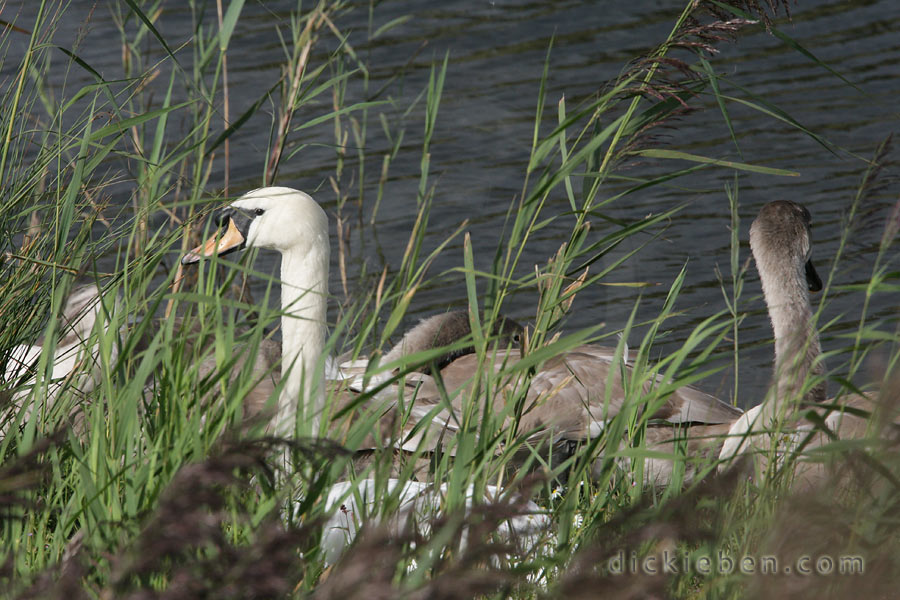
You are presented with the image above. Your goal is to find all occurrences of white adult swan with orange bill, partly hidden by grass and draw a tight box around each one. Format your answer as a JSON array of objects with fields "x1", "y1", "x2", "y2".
[{"x1": 182, "y1": 187, "x2": 546, "y2": 560}]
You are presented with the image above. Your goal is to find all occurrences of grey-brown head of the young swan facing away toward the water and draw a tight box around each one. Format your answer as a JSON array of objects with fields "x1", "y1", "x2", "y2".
[{"x1": 750, "y1": 200, "x2": 822, "y2": 292}]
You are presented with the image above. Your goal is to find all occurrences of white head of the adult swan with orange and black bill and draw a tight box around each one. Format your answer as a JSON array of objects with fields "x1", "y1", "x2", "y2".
[{"x1": 181, "y1": 187, "x2": 328, "y2": 264}]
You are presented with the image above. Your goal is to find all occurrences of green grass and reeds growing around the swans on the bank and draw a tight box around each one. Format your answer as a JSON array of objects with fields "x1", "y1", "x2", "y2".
[{"x1": 0, "y1": 0, "x2": 900, "y2": 598}]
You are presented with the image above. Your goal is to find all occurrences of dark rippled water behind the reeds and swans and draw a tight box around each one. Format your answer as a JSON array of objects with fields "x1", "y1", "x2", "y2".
[{"x1": 4, "y1": 0, "x2": 900, "y2": 406}]
